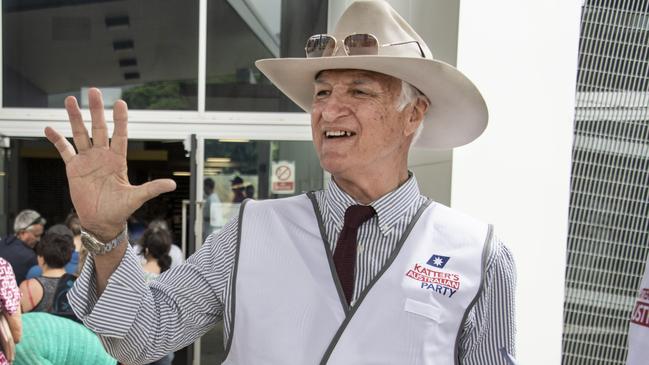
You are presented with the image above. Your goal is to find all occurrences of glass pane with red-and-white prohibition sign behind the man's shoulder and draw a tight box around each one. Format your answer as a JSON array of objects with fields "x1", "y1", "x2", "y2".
[{"x1": 203, "y1": 140, "x2": 323, "y2": 240}]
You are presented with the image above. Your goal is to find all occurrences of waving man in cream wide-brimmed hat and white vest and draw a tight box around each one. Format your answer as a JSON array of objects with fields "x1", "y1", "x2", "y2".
[{"x1": 45, "y1": 1, "x2": 514, "y2": 365}]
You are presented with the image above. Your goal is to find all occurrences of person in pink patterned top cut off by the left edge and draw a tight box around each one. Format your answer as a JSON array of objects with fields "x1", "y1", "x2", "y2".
[{"x1": 0, "y1": 257, "x2": 23, "y2": 365}]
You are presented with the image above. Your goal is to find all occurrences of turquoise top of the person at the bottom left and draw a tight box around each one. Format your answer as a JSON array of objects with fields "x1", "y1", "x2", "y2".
[{"x1": 13, "y1": 312, "x2": 117, "y2": 365}]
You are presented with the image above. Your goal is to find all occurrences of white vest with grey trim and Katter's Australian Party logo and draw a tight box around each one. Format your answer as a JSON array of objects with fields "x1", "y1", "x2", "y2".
[{"x1": 224, "y1": 195, "x2": 491, "y2": 365}]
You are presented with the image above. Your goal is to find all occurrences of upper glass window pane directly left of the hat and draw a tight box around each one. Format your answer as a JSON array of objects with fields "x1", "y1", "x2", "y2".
[{"x1": 205, "y1": 0, "x2": 328, "y2": 112}]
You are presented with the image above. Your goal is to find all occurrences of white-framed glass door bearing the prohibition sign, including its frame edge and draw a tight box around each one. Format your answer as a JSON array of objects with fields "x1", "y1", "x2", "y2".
[{"x1": 193, "y1": 137, "x2": 324, "y2": 365}]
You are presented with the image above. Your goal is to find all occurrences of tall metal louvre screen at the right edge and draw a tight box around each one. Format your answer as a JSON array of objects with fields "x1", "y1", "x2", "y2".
[{"x1": 563, "y1": 0, "x2": 649, "y2": 365}]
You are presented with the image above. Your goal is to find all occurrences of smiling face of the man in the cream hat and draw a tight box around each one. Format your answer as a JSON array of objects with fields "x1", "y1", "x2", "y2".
[{"x1": 311, "y1": 70, "x2": 410, "y2": 177}]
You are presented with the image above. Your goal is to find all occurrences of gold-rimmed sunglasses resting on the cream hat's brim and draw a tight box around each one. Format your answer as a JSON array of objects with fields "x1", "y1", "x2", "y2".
[{"x1": 304, "y1": 33, "x2": 426, "y2": 58}]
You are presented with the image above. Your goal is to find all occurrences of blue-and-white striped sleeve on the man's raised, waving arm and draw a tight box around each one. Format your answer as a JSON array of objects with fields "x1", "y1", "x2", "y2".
[{"x1": 69, "y1": 218, "x2": 238, "y2": 364}]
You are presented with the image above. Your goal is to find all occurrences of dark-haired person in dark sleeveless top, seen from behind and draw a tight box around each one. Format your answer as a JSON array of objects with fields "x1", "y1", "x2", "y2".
[{"x1": 20, "y1": 224, "x2": 75, "y2": 319}]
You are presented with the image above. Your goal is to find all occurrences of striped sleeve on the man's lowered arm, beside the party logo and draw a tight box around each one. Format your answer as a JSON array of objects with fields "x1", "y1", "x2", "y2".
[{"x1": 459, "y1": 236, "x2": 516, "y2": 365}]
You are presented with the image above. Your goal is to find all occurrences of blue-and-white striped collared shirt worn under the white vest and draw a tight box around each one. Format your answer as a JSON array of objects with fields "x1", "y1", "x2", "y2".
[{"x1": 69, "y1": 176, "x2": 515, "y2": 365}]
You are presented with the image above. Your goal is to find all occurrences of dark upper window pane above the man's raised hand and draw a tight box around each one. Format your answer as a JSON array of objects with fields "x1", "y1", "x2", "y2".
[{"x1": 2, "y1": 0, "x2": 198, "y2": 110}]
